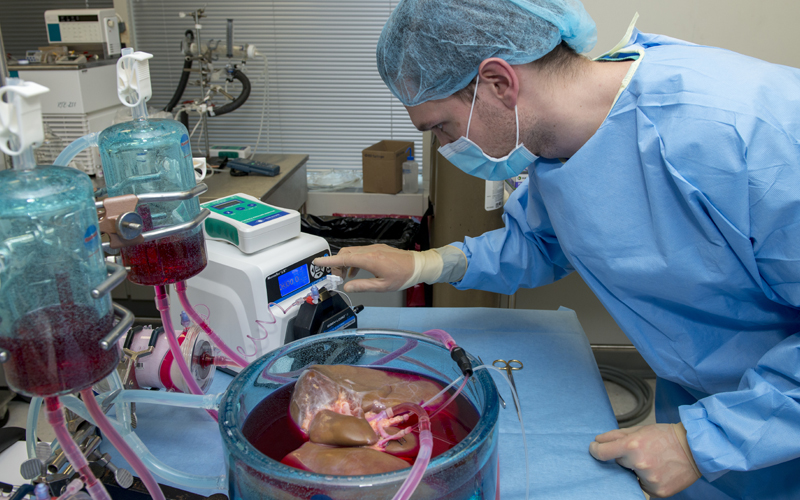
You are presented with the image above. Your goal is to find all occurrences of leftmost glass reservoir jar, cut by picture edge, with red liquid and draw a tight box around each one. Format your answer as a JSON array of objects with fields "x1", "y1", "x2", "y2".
[{"x1": 0, "y1": 166, "x2": 119, "y2": 396}]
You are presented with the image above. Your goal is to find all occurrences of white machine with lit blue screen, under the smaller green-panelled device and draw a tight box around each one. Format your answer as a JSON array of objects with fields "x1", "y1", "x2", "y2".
[{"x1": 170, "y1": 233, "x2": 333, "y2": 370}]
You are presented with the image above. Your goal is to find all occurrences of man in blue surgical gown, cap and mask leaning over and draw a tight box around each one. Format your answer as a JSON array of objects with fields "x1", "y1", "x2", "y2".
[{"x1": 318, "y1": 0, "x2": 800, "y2": 499}]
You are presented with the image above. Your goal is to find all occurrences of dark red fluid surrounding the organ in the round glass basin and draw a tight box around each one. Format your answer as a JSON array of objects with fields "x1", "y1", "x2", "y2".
[{"x1": 242, "y1": 370, "x2": 480, "y2": 464}]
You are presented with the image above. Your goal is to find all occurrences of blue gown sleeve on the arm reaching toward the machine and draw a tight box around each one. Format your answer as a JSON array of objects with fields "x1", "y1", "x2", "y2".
[{"x1": 451, "y1": 176, "x2": 573, "y2": 294}]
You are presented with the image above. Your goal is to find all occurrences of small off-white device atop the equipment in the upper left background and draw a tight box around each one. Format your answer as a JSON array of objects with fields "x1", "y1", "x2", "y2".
[{"x1": 44, "y1": 9, "x2": 122, "y2": 57}]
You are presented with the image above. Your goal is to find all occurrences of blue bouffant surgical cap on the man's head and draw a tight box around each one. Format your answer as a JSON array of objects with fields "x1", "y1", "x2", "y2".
[{"x1": 377, "y1": 0, "x2": 597, "y2": 106}]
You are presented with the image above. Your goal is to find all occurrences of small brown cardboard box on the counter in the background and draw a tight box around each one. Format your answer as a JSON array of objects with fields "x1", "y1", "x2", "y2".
[{"x1": 361, "y1": 141, "x2": 414, "y2": 194}]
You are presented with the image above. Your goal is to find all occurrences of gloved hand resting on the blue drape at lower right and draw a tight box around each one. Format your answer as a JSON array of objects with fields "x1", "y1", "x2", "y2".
[{"x1": 589, "y1": 424, "x2": 700, "y2": 498}]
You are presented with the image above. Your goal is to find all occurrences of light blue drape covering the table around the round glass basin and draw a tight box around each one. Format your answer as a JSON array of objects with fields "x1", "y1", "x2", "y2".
[{"x1": 98, "y1": 308, "x2": 644, "y2": 500}]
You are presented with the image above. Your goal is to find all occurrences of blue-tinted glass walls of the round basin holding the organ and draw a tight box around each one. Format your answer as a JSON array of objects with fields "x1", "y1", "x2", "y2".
[{"x1": 219, "y1": 330, "x2": 499, "y2": 500}]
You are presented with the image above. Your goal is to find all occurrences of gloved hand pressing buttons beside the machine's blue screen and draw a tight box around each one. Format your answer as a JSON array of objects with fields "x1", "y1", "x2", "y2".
[{"x1": 314, "y1": 245, "x2": 414, "y2": 292}]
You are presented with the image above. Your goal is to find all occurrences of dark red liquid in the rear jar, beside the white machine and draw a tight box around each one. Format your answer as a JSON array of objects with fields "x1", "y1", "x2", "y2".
[{"x1": 122, "y1": 230, "x2": 207, "y2": 286}]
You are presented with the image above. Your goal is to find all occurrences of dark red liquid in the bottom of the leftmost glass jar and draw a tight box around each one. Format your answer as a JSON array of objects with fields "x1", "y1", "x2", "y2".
[{"x1": 0, "y1": 304, "x2": 119, "y2": 396}]
